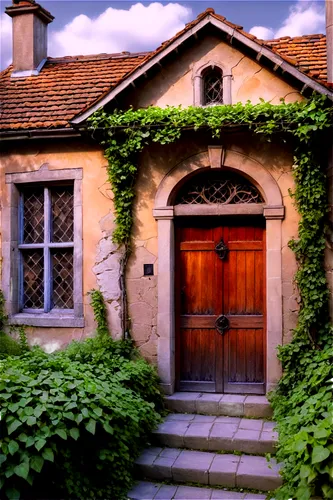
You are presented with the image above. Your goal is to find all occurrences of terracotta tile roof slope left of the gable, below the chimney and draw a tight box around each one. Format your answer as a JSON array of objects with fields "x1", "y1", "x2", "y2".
[{"x1": 0, "y1": 53, "x2": 146, "y2": 130}]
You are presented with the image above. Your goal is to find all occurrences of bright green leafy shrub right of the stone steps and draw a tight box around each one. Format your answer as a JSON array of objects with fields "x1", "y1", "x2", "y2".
[{"x1": 272, "y1": 340, "x2": 333, "y2": 500}]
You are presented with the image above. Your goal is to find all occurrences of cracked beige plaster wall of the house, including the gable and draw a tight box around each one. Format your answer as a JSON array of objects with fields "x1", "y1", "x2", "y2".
[{"x1": 0, "y1": 33, "x2": 332, "y2": 368}]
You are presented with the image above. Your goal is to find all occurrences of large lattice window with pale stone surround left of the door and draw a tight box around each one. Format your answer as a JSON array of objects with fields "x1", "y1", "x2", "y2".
[{"x1": 2, "y1": 164, "x2": 84, "y2": 328}]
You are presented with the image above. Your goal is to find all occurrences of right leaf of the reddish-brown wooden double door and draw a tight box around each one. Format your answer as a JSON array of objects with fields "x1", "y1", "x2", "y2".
[{"x1": 222, "y1": 224, "x2": 265, "y2": 394}]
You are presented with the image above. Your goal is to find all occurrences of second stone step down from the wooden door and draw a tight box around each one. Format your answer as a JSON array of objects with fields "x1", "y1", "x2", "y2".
[{"x1": 153, "y1": 413, "x2": 277, "y2": 455}]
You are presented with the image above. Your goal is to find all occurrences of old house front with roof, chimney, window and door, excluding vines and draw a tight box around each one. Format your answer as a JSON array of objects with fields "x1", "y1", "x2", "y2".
[{"x1": 0, "y1": 0, "x2": 333, "y2": 394}]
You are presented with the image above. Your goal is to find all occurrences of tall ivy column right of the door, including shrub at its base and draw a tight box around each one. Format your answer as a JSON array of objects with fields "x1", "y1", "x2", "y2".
[{"x1": 272, "y1": 108, "x2": 333, "y2": 500}]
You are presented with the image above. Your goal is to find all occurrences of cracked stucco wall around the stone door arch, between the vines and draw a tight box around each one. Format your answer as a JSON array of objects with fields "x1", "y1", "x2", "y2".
[{"x1": 127, "y1": 133, "x2": 299, "y2": 361}]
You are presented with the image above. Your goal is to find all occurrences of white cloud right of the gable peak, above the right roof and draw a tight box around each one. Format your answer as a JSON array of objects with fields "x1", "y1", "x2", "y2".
[{"x1": 250, "y1": 0, "x2": 325, "y2": 40}]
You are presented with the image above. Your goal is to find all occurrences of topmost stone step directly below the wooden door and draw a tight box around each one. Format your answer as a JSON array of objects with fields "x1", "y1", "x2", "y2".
[{"x1": 165, "y1": 392, "x2": 273, "y2": 418}]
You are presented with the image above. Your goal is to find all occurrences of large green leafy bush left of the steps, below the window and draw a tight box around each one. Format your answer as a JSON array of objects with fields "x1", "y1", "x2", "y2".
[{"x1": 0, "y1": 335, "x2": 162, "y2": 499}]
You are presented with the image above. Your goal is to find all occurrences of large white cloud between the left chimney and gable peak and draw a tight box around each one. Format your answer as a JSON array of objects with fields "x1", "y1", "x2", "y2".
[{"x1": 49, "y1": 2, "x2": 192, "y2": 56}]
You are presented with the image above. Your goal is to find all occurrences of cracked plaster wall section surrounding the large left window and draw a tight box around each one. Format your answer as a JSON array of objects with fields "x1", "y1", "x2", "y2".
[{"x1": 0, "y1": 139, "x2": 122, "y2": 350}]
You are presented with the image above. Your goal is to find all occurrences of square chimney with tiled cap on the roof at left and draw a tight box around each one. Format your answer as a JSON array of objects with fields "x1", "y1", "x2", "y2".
[{"x1": 6, "y1": 0, "x2": 54, "y2": 77}]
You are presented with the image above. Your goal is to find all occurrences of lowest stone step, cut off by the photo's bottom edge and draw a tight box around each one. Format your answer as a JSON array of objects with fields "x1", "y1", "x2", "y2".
[{"x1": 128, "y1": 481, "x2": 266, "y2": 500}]
